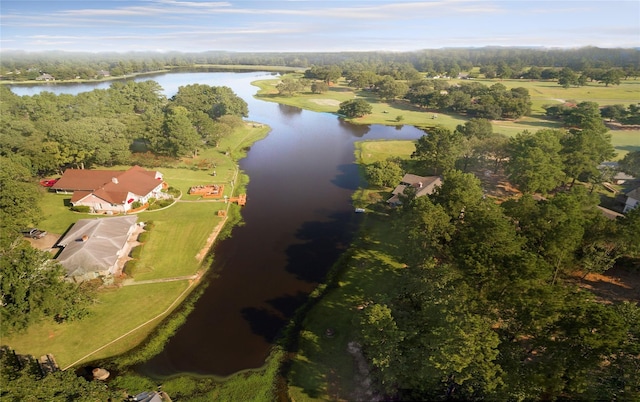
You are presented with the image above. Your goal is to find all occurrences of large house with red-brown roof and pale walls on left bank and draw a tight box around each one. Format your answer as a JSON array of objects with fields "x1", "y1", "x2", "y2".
[{"x1": 51, "y1": 166, "x2": 163, "y2": 213}]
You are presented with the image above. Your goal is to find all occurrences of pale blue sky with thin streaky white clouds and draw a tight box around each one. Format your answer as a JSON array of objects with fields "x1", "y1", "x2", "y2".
[{"x1": 0, "y1": 0, "x2": 640, "y2": 52}]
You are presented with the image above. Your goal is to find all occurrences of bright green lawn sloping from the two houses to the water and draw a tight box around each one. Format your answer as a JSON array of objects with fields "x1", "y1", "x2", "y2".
[{"x1": 2, "y1": 124, "x2": 269, "y2": 367}]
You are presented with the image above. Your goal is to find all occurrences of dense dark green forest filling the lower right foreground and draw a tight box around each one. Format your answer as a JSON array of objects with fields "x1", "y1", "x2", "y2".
[{"x1": 360, "y1": 153, "x2": 640, "y2": 400}]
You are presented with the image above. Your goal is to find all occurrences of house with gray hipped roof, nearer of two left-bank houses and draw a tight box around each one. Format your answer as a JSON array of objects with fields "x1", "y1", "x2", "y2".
[{"x1": 56, "y1": 216, "x2": 138, "y2": 282}]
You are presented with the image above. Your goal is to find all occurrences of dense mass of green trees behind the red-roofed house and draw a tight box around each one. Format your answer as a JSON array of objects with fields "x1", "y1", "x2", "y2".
[{"x1": 0, "y1": 80, "x2": 248, "y2": 176}]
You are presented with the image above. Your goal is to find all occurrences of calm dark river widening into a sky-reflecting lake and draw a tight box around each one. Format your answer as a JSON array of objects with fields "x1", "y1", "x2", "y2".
[{"x1": 12, "y1": 73, "x2": 424, "y2": 376}]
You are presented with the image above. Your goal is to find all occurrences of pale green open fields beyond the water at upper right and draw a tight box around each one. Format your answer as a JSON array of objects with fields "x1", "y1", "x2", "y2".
[{"x1": 254, "y1": 74, "x2": 640, "y2": 158}]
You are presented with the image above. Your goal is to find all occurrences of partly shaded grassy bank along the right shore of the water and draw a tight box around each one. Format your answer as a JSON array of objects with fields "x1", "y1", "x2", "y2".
[{"x1": 287, "y1": 141, "x2": 413, "y2": 401}]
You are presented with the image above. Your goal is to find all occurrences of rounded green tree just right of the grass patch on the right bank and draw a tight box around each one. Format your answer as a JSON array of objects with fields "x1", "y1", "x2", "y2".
[{"x1": 411, "y1": 126, "x2": 461, "y2": 174}]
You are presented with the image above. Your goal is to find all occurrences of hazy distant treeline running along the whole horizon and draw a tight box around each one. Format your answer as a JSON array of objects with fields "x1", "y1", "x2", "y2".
[{"x1": 0, "y1": 47, "x2": 640, "y2": 81}]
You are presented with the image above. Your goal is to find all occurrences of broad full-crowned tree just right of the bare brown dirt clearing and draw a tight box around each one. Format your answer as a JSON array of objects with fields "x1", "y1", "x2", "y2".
[{"x1": 506, "y1": 130, "x2": 564, "y2": 193}]
